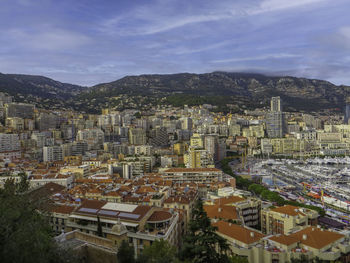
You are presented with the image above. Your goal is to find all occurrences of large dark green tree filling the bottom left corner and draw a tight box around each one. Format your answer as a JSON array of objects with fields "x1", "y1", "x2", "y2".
[{"x1": 0, "y1": 176, "x2": 74, "y2": 263}]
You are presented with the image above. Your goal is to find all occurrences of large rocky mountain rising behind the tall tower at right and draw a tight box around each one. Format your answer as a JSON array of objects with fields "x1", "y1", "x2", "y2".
[{"x1": 78, "y1": 72, "x2": 350, "y2": 110}]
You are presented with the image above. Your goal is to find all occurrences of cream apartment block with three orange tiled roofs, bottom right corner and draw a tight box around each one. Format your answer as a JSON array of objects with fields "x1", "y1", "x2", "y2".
[{"x1": 213, "y1": 221, "x2": 350, "y2": 263}]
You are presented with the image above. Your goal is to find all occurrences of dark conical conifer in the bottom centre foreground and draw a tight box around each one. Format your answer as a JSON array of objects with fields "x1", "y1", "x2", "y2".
[{"x1": 180, "y1": 200, "x2": 230, "y2": 263}]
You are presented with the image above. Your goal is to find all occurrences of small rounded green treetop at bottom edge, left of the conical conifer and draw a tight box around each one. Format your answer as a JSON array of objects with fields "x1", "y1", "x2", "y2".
[{"x1": 137, "y1": 239, "x2": 179, "y2": 263}]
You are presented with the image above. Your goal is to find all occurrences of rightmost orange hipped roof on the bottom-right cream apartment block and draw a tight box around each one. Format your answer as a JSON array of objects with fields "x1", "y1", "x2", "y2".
[{"x1": 290, "y1": 226, "x2": 345, "y2": 249}]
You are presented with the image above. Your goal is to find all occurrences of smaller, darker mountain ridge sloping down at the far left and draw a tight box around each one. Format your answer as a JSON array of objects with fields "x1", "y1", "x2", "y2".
[{"x1": 0, "y1": 73, "x2": 84, "y2": 100}]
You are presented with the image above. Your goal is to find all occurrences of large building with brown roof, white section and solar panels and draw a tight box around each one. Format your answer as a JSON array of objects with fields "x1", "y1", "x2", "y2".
[{"x1": 65, "y1": 200, "x2": 181, "y2": 256}]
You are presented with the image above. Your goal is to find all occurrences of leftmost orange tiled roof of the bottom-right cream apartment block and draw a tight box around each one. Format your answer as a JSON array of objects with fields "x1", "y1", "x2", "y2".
[{"x1": 213, "y1": 221, "x2": 264, "y2": 245}]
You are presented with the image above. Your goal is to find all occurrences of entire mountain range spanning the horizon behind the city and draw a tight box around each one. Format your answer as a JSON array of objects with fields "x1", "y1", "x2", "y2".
[{"x1": 0, "y1": 72, "x2": 350, "y2": 113}]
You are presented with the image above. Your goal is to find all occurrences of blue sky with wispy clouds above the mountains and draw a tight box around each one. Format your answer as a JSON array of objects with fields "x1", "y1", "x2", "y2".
[{"x1": 0, "y1": 0, "x2": 350, "y2": 86}]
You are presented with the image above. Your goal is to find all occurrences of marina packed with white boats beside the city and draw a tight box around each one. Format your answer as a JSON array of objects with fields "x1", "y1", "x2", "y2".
[{"x1": 243, "y1": 157, "x2": 350, "y2": 224}]
